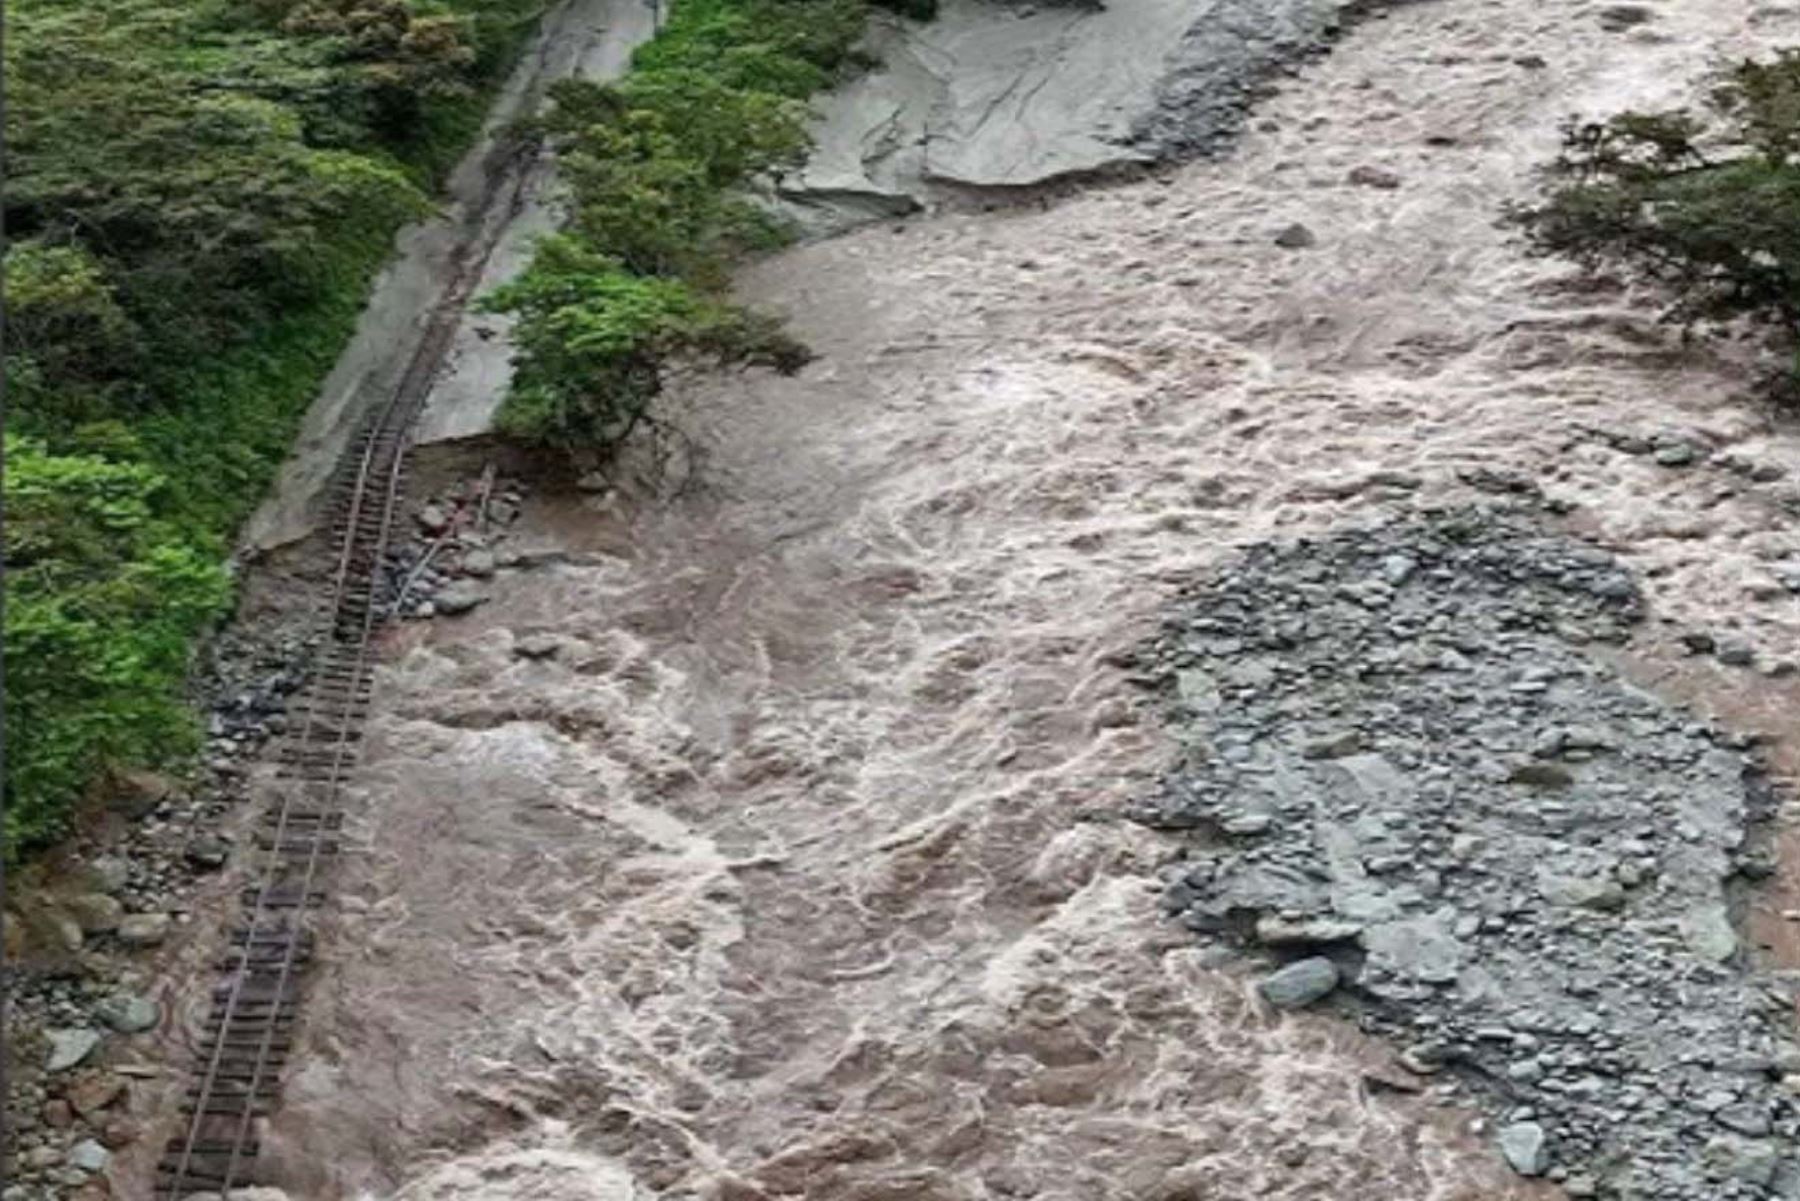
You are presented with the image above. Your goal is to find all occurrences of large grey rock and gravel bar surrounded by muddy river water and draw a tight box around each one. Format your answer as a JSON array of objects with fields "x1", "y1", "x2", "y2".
[{"x1": 1143, "y1": 506, "x2": 1800, "y2": 1201}]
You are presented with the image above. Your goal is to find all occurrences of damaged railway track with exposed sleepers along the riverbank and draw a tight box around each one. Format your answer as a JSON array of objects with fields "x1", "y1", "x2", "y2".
[{"x1": 155, "y1": 135, "x2": 529, "y2": 1201}]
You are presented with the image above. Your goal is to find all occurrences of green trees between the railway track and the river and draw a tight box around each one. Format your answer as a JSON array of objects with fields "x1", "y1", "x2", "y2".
[{"x1": 488, "y1": 0, "x2": 892, "y2": 454}]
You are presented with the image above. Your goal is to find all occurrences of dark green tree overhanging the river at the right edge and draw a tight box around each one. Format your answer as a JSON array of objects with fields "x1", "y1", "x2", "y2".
[{"x1": 1510, "y1": 50, "x2": 1800, "y2": 370}]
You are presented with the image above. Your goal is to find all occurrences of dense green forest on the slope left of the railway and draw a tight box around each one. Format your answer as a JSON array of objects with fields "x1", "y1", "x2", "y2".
[{"x1": 4, "y1": 0, "x2": 542, "y2": 855}]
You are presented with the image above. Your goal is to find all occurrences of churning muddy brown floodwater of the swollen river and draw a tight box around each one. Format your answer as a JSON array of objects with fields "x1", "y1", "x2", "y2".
[{"x1": 133, "y1": 0, "x2": 1800, "y2": 1201}]
